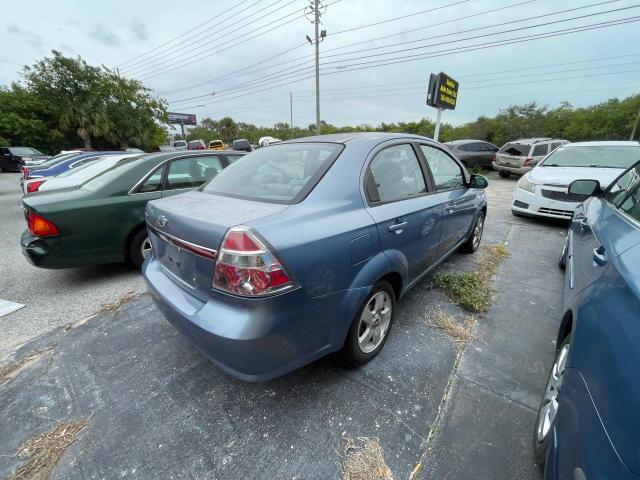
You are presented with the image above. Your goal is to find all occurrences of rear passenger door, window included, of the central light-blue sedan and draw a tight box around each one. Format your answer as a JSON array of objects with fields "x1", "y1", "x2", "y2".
[{"x1": 364, "y1": 143, "x2": 442, "y2": 282}]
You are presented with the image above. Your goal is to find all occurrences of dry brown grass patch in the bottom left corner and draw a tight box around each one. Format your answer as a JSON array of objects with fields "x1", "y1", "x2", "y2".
[{"x1": 9, "y1": 417, "x2": 89, "y2": 480}]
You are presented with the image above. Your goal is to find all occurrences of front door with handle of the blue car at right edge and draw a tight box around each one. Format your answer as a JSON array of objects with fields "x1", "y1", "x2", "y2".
[{"x1": 565, "y1": 165, "x2": 640, "y2": 294}]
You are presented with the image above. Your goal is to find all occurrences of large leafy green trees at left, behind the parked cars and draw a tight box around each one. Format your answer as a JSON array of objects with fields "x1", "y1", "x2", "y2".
[{"x1": 0, "y1": 51, "x2": 167, "y2": 153}]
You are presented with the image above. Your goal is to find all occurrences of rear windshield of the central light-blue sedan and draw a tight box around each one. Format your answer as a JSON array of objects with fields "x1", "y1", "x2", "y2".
[{"x1": 202, "y1": 143, "x2": 343, "y2": 204}]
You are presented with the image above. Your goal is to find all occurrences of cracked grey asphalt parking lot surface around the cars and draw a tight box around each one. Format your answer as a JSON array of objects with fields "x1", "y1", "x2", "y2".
[{"x1": 0, "y1": 173, "x2": 566, "y2": 479}]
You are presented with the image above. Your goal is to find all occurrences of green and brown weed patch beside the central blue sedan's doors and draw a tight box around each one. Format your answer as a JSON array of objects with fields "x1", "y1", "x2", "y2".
[{"x1": 433, "y1": 244, "x2": 509, "y2": 313}]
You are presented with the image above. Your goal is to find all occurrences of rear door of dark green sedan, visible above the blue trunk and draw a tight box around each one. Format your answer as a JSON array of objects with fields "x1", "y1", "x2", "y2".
[{"x1": 162, "y1": 155, "x2": 227, "y2": 197}]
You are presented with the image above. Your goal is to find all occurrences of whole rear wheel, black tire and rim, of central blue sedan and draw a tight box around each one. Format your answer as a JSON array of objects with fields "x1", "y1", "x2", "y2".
[{"x1": 341, "y1": 281, "x2": 396, "y2": 365}]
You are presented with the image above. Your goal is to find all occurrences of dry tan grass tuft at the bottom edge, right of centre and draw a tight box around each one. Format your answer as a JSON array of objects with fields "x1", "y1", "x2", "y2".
[{"x1": 342, "y1": 437, "x2": 393, "y2": 480}]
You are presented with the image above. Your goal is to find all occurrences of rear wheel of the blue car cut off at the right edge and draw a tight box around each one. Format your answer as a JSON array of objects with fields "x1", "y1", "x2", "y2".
[{"x1": 533, "y1": 334, "x2": 571, "y2": 465}]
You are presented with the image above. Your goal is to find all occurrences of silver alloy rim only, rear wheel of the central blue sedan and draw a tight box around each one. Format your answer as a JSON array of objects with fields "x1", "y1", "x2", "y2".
[{"x1": 358, "y1": 291, "x2": 393, "y2": 353}]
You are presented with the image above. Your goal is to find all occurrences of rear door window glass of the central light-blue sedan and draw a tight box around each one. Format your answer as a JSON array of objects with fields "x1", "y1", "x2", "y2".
[{"x1": 369, "y1": 145, "x2": 427, "y2": 202}]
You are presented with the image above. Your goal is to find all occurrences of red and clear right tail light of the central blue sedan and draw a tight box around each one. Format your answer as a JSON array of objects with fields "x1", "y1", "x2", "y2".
[{"x1": 213, "y1": 227, "x2": 296, "y2": 297}]
